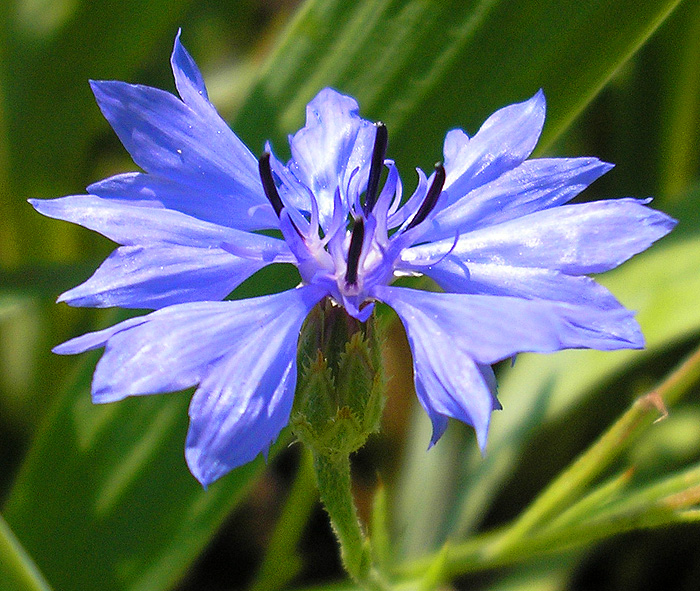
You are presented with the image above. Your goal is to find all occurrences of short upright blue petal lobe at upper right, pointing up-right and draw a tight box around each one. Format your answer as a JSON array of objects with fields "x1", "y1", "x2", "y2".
[{"x1": 444, "y1": 90, "x2": 546, "y2": 203}]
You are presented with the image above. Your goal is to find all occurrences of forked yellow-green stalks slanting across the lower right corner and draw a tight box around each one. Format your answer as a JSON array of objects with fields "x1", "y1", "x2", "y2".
[{"x1": 395, "y1": 340, "x2": 700, "y2": 581}]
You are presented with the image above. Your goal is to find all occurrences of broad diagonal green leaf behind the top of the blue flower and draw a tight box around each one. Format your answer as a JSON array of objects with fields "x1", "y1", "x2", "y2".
[{"x1": 233, "y1": 0, "x2": 680, "y2": 174}]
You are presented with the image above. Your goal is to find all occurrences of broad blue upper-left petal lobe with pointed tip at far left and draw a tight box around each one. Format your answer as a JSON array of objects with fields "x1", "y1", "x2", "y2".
[{"x1": 91, "y1": 81, "x2": 269, "y2": 214}]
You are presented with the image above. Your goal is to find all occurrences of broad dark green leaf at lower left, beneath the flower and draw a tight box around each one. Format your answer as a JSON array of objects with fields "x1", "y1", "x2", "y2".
[{"x1": 4, "y1": 346, "x2": 264, "y2": 591}]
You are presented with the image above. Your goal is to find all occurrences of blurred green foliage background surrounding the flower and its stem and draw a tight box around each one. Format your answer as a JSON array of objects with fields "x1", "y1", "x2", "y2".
[{"x1": 0, "y1": 0, "x2": 700, "y2": 591}]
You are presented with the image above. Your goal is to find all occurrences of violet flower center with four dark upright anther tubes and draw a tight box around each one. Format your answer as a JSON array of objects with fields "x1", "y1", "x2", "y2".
[{"x1": 258, "y1": 122, "x2": 446, "y2": 318}]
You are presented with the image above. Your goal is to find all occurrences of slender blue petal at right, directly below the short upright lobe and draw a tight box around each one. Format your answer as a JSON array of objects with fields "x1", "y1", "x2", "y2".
[{"x1": 424, "y1": 158, "x2": 613, "y2": 240}]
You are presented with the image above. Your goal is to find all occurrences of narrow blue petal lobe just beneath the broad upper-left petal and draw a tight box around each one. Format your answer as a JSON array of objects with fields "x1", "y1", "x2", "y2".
[{"x1": 88, "y1": 172, "x2": 277, "y2": 230}]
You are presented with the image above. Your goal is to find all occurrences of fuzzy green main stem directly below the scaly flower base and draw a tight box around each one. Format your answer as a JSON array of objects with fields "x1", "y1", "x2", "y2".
[{"x1": 314, "y1": 453, "x2": 388, "y2": 591}]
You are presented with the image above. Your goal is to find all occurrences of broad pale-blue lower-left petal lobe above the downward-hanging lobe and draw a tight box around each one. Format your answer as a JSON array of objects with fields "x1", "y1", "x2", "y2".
[{"x1": 89, "y1": 286, "x2": 324, "y2": 403}]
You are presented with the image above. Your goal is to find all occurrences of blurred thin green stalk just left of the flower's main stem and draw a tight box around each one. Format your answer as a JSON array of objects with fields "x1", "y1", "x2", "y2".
[{"x1": 250, "y1": 448, "x2": 318, "y2": 591}]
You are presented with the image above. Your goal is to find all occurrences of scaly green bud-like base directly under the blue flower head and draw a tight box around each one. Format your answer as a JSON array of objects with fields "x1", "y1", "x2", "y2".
[{"x1": 291, "y1": 300, "x2": 386, "y2": 456}]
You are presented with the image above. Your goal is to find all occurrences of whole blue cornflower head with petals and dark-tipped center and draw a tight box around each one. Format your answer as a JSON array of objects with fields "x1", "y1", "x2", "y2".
[{"x1": 32, "y1": 31, "x2": 675, "y2": 485}]
